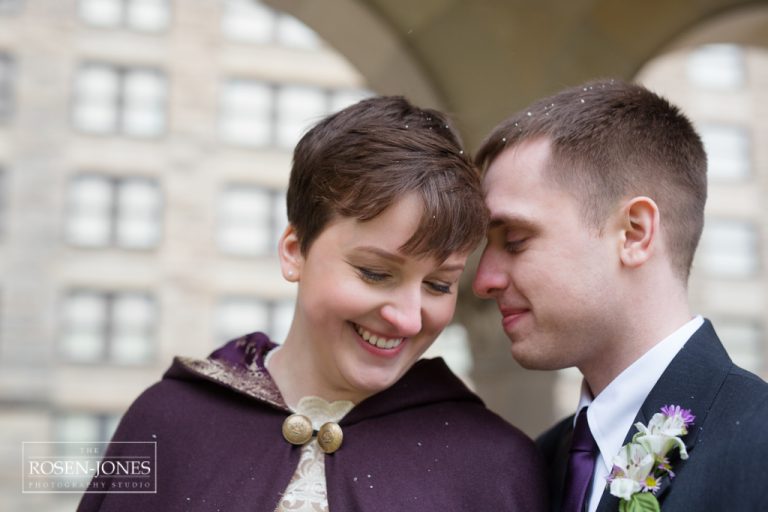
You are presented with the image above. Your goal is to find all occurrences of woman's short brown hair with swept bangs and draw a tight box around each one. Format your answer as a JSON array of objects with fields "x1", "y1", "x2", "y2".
[{"x1": 287, "y1": 96, "x2": 488, "y2": 261}]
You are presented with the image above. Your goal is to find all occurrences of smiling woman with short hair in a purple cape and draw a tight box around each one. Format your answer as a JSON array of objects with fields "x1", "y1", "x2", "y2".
[{"x1": 79, "y1": 97, "x2": 544, "y2": 512}]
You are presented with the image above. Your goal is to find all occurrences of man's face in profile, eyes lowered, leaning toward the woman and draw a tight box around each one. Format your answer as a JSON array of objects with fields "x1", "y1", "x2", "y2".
[{"x1": 473, "y1": 139, "x2": 621, "y2": 370}]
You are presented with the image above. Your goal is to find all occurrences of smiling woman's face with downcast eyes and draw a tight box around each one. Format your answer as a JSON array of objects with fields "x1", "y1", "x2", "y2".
[{"x1": 280, "y1": 194, "x2": 467, "y2": 402}]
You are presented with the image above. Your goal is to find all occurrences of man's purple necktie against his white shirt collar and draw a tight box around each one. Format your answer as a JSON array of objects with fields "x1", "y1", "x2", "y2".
[{"x1": 561, "y1": 407, "x2": 597, "y2": 512}]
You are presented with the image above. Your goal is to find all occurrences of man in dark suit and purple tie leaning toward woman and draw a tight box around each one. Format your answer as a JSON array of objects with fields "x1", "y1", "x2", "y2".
[{"x1": 474, "y1": 80, "x2": 768, "y2": 512}]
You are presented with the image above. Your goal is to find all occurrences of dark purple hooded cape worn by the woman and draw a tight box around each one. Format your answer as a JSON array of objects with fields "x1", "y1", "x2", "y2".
[{"x1": 78, "y1": 333, "x2": 546, "y2": 512}]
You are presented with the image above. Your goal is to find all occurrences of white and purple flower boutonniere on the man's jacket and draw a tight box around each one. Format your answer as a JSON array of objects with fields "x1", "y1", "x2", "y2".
[{"x1": 607, "y1": 405, "x2": 696, "y2": 512}]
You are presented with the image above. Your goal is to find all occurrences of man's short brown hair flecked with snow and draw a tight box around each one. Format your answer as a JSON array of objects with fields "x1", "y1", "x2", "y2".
[{"x1": 475, "y1": 80, "x2": 707, "y2": 282}]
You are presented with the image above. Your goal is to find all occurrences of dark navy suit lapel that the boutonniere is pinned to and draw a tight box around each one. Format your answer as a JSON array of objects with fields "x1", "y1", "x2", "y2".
[{"x1": 597, "y1": 320, "x2": 733, "y2": 512}]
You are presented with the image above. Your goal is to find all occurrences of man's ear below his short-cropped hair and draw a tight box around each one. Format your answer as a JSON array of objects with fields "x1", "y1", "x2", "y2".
[{"x1": 620, "y1": 196, "x2": 660, "y2": 267}]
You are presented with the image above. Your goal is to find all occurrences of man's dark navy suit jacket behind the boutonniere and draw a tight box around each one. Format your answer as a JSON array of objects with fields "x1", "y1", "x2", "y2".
[{"x1": 537, "y1": 320, "x2": 768, "y2": 512}]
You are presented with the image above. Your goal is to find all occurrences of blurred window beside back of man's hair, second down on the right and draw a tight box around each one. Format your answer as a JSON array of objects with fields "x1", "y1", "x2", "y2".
[{"x1": 700, "y1": 124, "x2": 752, "y2": 180}]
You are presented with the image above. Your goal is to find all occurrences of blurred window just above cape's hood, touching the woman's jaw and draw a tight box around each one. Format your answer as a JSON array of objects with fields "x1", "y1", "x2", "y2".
[{"x1": 216, "y1": 297, "x2": 294, "y2": 343}]
